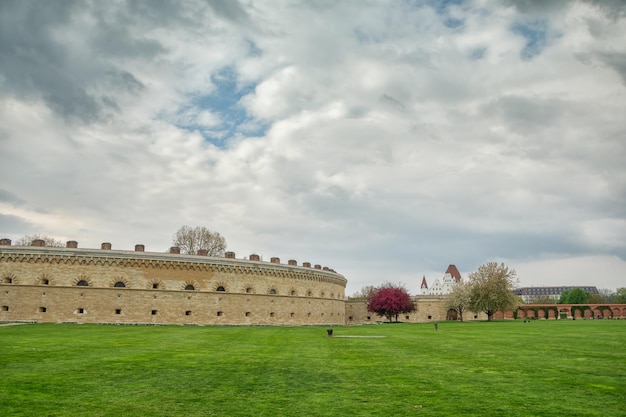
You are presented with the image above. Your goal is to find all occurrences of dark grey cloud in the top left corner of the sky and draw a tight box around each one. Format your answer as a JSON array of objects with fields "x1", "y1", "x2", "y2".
[{"x1": 0, "y1": 1, "x2": 165, "y2": 122}]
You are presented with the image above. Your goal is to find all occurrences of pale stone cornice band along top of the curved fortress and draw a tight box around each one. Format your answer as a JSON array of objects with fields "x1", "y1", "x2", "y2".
[{"x1": 0, "y1": 246, "x2": 347, "y2": 287}]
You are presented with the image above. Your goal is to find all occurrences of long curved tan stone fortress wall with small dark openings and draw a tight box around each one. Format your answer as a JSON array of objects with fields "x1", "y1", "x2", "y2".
[{"x1": 0, "y1": 239, "x2": 347, "y2": 325}]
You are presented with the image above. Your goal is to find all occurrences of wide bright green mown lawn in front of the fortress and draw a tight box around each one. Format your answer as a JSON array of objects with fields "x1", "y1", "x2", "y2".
[{"x1": 0, "y1": 320, "x2": 626, "y2": 417}]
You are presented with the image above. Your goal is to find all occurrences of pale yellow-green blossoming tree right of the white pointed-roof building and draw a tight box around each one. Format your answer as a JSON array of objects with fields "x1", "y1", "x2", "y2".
[{"x1": 469, "y1": 262, "x2": 517, "y2": 321}]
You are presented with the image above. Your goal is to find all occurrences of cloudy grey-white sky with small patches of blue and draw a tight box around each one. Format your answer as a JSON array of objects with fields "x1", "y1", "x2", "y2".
[{"x1": 0, "y1": 0, "x2": 626, "y2": 295}]
